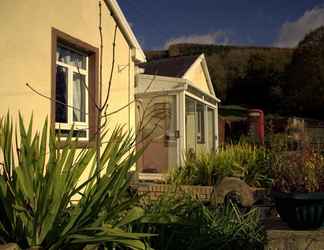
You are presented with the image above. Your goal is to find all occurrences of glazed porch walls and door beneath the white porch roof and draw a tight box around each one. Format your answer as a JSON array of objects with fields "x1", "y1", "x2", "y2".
[{"x1": 136, "y1": 83, "x2": 218, "y2": 174}]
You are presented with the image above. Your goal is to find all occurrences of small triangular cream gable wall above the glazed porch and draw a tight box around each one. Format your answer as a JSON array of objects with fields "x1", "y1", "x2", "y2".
[{"x1": 184, "y1": 60, "x2": 213, "y2": 95}]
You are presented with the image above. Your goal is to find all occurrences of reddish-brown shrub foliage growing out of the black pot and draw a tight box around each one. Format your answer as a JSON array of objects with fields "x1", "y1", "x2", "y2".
[{"x1": 269, "y1": 134, "x2": 324, "y2": 192}]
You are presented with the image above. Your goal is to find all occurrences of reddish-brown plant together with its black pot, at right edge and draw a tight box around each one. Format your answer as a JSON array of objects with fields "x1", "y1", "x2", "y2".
[{"x1": 272, "y1": 146, "x2": 324, "y2": 230}]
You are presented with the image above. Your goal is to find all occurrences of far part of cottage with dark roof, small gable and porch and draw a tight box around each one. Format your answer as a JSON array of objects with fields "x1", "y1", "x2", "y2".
[{"x1": 135, "y1": 54, "x2": 220, "y2": 178}]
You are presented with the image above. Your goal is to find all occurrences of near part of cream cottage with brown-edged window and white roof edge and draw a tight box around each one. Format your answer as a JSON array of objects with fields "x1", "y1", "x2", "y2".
[{"x1": 0, "y1": 0, "x2": 145, "y2": 147}]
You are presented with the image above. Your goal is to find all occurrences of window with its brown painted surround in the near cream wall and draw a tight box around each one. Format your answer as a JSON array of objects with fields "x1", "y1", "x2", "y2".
[{"x1": 52, "y1": 29, "x2": 98, "y2": 146}]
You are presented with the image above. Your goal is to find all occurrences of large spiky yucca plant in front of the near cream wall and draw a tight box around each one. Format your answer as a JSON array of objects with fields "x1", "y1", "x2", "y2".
[{"x1": 0, "y1": 115, "x2": 148, "y2": 249}]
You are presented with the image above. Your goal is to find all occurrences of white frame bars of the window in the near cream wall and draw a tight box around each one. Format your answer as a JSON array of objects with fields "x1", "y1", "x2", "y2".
[{"x1": 55, "y1": 43, "x2": 89, "y2": 141}]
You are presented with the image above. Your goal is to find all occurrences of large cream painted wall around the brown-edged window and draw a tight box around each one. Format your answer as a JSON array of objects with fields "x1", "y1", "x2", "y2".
[{"x1": 0, "y1": 0, "x2": 135, "y2": 134}]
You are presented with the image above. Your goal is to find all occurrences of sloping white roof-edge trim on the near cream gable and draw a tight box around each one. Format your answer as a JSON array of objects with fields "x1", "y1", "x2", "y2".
[{"x1": 104, "y1": 0, "x2": 146, "y2": 62}]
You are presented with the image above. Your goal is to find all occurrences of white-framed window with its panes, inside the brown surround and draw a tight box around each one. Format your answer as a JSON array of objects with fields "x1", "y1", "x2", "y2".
[{"x1": 55, "y1": 44, "x2": 89, "y2": 139}]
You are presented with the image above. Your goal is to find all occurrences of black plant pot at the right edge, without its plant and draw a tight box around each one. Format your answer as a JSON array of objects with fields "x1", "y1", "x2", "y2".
[{"x1": 272, "y1": 192, "x2": 324, "y2": 230}]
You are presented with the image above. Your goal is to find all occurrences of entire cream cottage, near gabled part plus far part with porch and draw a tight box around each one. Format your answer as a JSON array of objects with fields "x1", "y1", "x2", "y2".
[{"x1": 0, "y1": 0, "x2": 219, "y2": 181}]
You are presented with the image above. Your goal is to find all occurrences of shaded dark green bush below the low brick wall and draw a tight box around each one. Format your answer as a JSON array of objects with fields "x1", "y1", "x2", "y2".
[{"x1": 138, "y1": 192, "x2": 265, "y2": 250}]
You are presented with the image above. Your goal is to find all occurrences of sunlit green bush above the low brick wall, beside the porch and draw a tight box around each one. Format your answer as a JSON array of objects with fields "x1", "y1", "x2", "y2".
[{"x1": 169, "y1": 144, "x2": 271, "y2": 187}]
